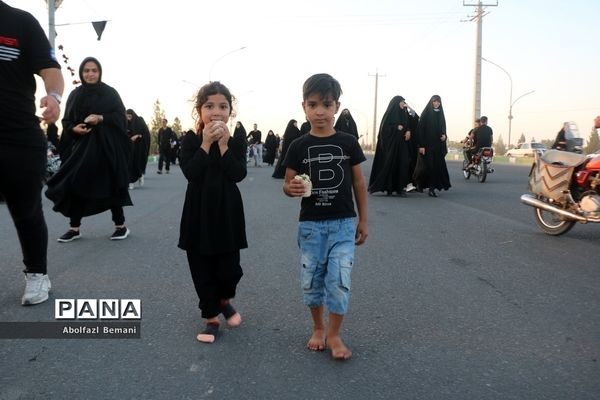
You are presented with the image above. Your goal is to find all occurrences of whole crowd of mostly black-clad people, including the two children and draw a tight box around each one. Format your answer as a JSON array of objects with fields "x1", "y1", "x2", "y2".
[{"x1": 9, "y1": 0, "x2": 600, "y2": 360}]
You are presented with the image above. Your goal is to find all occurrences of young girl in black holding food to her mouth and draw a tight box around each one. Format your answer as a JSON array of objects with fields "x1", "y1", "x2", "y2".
[{"x1": 179, "y1": 82, "x2": 248, "y2": 343}]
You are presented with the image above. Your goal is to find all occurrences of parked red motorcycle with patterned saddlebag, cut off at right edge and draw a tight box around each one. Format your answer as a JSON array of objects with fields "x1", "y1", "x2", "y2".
[{"x1": 521, "y1": 150, "x2": 600, "y2": 236}]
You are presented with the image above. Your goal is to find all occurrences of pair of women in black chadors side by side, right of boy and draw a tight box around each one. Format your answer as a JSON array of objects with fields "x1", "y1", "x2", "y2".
[{"x1": 369, "y1": 95, "x2": 451, "y2": 197}]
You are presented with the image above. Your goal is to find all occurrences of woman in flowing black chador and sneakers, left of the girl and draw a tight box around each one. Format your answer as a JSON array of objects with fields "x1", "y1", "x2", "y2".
[{"x1": 46, "y1": 57, "x2": 132, "y2": 242}]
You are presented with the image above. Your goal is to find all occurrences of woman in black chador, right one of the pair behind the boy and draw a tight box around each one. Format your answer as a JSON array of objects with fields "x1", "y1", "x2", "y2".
[{"x1": 417, "y1": 95, "x2": 450, "y2": 197}]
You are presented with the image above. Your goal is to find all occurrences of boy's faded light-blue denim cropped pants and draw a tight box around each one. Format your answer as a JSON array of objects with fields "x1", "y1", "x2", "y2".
[{"x1": 298, "y1": 218, "x2": 356, "y2": 315}]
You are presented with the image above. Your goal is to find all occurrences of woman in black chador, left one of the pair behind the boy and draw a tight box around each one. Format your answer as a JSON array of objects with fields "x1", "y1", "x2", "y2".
[{"x1": 369, "y1": 96, "x2": 411, "y2": 196}]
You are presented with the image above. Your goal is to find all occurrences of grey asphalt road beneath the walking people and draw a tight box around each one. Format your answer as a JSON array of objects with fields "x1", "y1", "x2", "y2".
[{"x1": 0, "y1": 160, "x2": 600, "y2": 400}]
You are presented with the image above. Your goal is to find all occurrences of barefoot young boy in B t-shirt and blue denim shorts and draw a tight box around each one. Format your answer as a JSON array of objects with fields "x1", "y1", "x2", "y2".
[{"x1": 283, "y1": 74, "x2": 368, "y2": 360}]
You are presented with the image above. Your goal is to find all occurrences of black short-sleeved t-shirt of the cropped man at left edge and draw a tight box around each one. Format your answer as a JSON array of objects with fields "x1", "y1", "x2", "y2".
[{"x1": 0, "y1": 3, "x2": 60, "y2": 147}]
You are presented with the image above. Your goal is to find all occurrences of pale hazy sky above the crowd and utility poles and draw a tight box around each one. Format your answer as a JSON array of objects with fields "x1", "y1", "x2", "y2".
[{"x1": 5, "y1": 0, "x2": 600, "y2": 144}]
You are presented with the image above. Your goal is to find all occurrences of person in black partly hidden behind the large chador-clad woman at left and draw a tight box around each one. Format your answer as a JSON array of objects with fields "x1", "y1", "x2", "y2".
[{"x1": 127, "y1": 109, "x2": 150, "y2": 189}]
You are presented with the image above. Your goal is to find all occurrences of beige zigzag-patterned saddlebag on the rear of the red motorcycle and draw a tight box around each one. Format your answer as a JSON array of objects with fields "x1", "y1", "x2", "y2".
[{"x1": 529, "y1": 150, "x2": 585, "y2": 203}]
